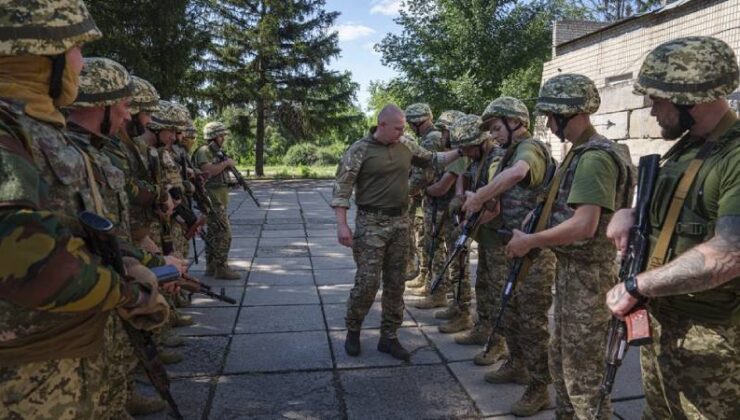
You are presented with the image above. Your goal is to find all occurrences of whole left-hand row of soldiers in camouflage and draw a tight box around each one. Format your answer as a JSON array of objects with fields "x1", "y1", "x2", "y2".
[{"x1": 0, "y1": 0, "x2": 240, "y2": 419}]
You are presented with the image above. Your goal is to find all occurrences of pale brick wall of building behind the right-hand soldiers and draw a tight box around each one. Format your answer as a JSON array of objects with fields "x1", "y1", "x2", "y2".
[{"x1": 536, "y1": 0, "x2": 740, "y2": 162}]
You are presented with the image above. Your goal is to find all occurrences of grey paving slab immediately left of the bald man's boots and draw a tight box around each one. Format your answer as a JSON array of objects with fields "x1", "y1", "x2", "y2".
[{"x1": 224, "y1": 331, "x2": 332, "y2": 373}]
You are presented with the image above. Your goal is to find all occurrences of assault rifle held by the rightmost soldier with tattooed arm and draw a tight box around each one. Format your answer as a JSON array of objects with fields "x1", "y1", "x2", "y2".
[{"x1": 596, "y1": 154, "x2": 660, "y2": 415}]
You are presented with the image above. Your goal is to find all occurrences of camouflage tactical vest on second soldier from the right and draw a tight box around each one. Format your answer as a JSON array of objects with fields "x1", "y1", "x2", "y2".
[{"x1": 548, "y1": 134, "x2": 637, "y2": 261}]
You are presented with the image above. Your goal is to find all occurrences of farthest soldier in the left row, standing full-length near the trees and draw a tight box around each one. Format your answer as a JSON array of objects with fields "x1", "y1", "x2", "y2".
[{"x1": 193, "y1": 121, "x2": 241, "y2": 280}]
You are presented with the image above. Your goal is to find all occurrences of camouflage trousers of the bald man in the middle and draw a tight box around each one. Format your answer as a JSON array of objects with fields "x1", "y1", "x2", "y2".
[{"x1": 345, "y1": 211, "x2": 410, "y2": 338}]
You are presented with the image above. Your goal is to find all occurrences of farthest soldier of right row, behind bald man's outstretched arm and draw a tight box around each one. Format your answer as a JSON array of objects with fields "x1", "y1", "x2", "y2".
[{"x1": 405, "y1": 103, "x2": 440, "y2": 288}]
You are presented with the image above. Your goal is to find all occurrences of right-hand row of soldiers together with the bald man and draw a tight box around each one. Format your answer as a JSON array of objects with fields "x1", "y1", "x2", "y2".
[{"x1": 332, "y1": 37, "x2": 740, "y2": 419}]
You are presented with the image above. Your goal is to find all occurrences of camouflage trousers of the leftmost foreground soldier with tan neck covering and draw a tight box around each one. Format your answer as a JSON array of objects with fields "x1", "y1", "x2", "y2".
[{"x1": 0, "y1": 355, "x2": 104, "y2": 420}]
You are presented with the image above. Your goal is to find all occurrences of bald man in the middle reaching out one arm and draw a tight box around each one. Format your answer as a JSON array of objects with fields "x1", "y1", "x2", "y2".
[{"x1": 331, "y1": 105, "x2": 460, "y2": 360}]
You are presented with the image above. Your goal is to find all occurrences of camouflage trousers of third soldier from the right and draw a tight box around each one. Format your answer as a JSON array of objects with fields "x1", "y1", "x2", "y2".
[{"x1": 502, "y1": 250, "x2": 556, "y2": 384}]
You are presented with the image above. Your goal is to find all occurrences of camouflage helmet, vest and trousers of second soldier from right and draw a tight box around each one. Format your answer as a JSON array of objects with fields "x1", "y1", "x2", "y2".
[{"x1": 537, "y1": 74, "x2": 634, "y2": 419}]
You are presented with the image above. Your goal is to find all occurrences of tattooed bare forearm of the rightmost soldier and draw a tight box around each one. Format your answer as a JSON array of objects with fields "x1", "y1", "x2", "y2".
[{"x1": 638, "y1": 216, "x2": 740, "y2": 297}]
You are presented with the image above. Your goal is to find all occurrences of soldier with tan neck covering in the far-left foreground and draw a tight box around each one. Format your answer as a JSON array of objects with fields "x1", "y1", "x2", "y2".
[{"x1": 0, "y1": 0, "x2": 167, "y2": 419}]
